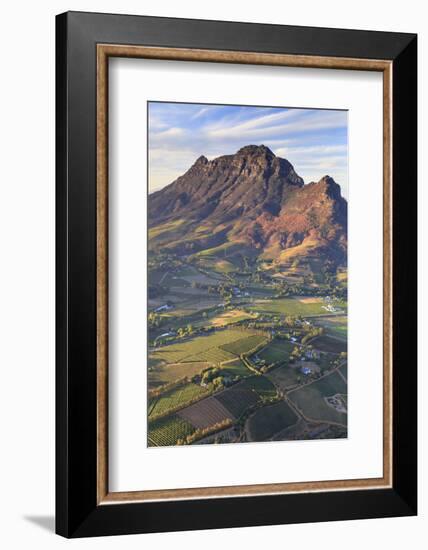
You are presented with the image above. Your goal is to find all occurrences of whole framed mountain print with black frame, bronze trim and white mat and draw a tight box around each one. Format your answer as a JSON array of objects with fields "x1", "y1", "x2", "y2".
[{"x1": 57, "y1": 12, "x2": 417, "y2": 537}]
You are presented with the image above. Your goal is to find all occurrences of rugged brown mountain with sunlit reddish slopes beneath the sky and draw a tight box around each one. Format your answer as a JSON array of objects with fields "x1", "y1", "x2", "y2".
[{"x1": 148, "y1": 145, "x2": 347, "y2": 265}]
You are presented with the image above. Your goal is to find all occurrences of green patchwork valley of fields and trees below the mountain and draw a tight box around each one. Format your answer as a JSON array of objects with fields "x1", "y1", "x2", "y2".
[{"x1": 147, "y1": 257, "x2": 347, "y2": 446}]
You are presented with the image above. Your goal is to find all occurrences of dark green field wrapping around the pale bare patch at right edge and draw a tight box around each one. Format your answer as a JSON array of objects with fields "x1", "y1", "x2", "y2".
[{"x1": 288, "y1": 372, "x2": 347, "y2": 425}]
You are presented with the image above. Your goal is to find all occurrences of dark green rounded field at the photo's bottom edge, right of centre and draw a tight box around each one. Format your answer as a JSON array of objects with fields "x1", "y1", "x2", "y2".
[{"x1": 247, "y1": 401, "x2": 297, "y2": 441}]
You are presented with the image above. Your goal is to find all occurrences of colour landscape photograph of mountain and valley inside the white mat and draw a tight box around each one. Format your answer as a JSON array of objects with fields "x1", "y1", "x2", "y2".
[{"x1": 146, "y1": 101, "x2": 352, "y2": 447}]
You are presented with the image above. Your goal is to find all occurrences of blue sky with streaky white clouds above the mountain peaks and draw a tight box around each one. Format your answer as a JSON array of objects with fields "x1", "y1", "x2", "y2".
[{"x1": 149, "y1": 102, "x2": 348, "y2": 197}]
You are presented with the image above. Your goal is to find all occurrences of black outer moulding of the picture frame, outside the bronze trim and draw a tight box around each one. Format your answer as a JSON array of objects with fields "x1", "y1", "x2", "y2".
[{"x1": 56, "y1": 12, "x2": 417, "y2": 537}]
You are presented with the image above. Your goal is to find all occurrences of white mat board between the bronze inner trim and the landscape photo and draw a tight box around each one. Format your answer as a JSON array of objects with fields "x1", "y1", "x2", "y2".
[{"x1": 109, "y1": 59, "x2": 383, "y2": 491}]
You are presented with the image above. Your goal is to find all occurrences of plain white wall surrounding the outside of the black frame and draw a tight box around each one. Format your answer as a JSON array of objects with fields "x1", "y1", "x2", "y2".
[{"x1": 0, "y1": 0, "x2": 422, "y2": 550}]
